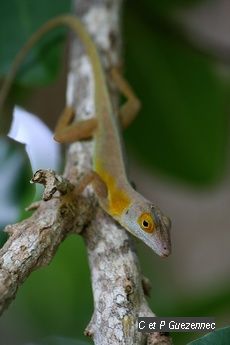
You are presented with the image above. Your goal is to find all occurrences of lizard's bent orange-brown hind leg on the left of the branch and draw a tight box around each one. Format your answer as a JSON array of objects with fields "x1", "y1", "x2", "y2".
[{"x1": 54, "y1": 107, "x2": 97, "y2": 144}]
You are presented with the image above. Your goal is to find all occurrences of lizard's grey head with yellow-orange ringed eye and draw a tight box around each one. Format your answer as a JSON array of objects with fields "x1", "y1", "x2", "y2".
[{"x1": 120, "y1": 198, "x2": 171, "y2": 257}]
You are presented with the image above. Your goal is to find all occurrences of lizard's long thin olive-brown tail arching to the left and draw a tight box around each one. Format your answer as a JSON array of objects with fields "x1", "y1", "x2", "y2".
[{"x1": 0, "y1": 15, "x2": 107, "y2": 113}]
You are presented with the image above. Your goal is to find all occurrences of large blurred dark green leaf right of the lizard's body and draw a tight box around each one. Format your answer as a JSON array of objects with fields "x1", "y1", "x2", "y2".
[{"x1": 125, "y1": 11, "x2": 228, "y2": 184}]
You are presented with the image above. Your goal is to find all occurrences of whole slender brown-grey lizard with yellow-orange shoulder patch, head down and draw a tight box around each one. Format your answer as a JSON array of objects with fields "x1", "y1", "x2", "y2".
[{"x1": 0, "y1": 15, "x2": 171, "y2": 256}]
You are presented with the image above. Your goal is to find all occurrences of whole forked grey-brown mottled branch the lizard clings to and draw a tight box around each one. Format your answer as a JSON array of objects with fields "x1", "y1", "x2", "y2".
[{"x1": 0, "y1": 0, "x2": 171, "y2": 345}]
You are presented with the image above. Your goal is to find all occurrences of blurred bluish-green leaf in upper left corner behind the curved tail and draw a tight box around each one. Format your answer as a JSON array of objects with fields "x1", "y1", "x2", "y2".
[{"x1": 0, "y1": 0, "x2": 70, "y2": 86}]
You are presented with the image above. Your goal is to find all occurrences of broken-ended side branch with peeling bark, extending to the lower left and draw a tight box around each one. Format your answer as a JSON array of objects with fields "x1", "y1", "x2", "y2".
[{"x1": 0, "y1": 171, "x2": 92, "y2": 314}]
